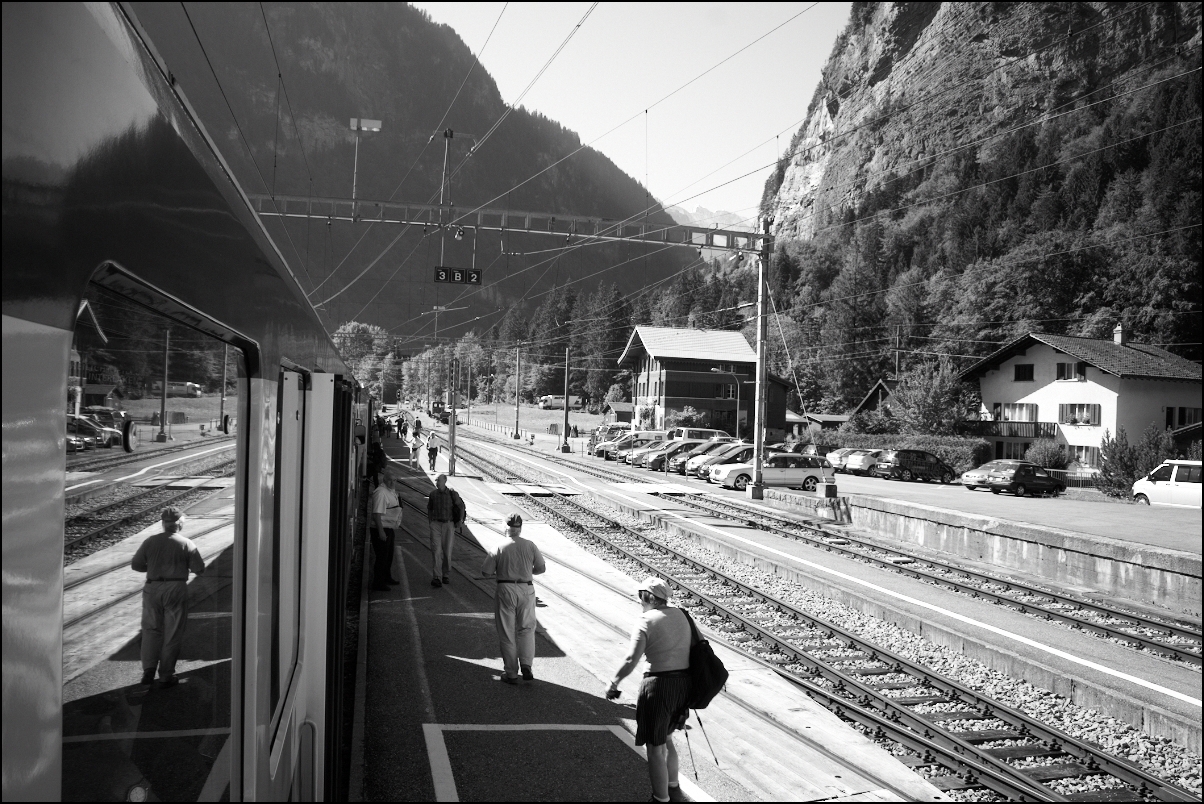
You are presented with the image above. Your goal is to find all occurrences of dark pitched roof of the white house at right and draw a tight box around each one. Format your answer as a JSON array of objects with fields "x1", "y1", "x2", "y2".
[{"x1": 961, "y1": 332, "x2": 1200, "y2": 383}]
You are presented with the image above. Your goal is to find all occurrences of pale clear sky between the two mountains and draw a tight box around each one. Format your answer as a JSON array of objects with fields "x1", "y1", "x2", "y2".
[{"x1": 414, "y1": 2, "x2": 850, "y2": 225}]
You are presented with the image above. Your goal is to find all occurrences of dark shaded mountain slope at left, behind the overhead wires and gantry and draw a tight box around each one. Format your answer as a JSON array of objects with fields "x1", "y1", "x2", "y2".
[{"x1": 134, "y1": 2, "x2": 692, "y2": 339}]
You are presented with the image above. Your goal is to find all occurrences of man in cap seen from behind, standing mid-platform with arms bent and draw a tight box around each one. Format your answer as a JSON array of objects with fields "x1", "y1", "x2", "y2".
[{"x1": 480, "y1": 514, "x2": 547, "y2": 684}]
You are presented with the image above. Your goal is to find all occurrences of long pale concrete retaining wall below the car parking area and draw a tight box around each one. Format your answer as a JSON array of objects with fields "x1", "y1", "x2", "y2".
[{"x1": 765, "y1": 489, "x2": 1202, "y2": 617}]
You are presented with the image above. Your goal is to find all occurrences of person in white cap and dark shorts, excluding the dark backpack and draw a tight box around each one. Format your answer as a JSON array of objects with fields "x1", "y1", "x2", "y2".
[{"x1": 606, "y1": 578, "x2": 694, "y2": 802}]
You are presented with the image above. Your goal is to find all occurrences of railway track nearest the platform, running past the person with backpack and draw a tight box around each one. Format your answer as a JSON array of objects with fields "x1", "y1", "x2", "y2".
[{"x1": 450, "y1": 448, "x2": 1197, "y2": 802}]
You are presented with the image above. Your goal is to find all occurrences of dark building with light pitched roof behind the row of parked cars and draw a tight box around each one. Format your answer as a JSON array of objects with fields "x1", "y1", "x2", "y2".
[{"x1": 619, "y1": 326, "x2": 789, "y2": 441}]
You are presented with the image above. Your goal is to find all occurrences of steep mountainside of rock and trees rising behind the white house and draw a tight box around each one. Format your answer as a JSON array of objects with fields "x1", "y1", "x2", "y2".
[{"x1": 762, "y1": 2, "x2": 1202, "y2": 410}]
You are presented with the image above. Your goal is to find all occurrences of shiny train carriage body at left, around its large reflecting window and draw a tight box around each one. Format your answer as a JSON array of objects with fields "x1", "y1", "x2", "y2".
[{"x1": 2, "y1": 4, "x2": 374, "y2": 800}]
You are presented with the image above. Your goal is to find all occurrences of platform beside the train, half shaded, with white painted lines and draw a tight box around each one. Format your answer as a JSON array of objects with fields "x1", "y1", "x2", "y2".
[{"x1": 350, "y1": 439, "x2": 948, "y2": 800}]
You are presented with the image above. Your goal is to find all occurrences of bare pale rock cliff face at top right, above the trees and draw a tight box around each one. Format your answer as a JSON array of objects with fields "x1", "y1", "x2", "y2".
[{"x1": 762, "y1": 2, "x2": 1200, "y2": 240}]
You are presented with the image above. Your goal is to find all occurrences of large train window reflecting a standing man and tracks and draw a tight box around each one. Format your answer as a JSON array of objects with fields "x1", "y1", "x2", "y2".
[{"x1": 61, "y1": 284, "x2": 249, "y2": 802}]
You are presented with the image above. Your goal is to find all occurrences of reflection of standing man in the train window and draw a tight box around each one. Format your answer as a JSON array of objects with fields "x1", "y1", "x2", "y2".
[{"x1": 130, "y1": 506, "x2": 205, "y2": 687}]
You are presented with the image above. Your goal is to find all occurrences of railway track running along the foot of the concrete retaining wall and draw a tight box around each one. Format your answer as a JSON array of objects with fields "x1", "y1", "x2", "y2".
[{"x1": 459, "y1": 435, "x2": 1204, "y2": 668}]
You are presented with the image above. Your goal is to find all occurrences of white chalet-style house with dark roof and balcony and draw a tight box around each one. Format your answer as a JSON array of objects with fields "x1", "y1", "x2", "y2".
[{"x1": 962, "y1": 326, "x2": 1200, "y2": 468}]
